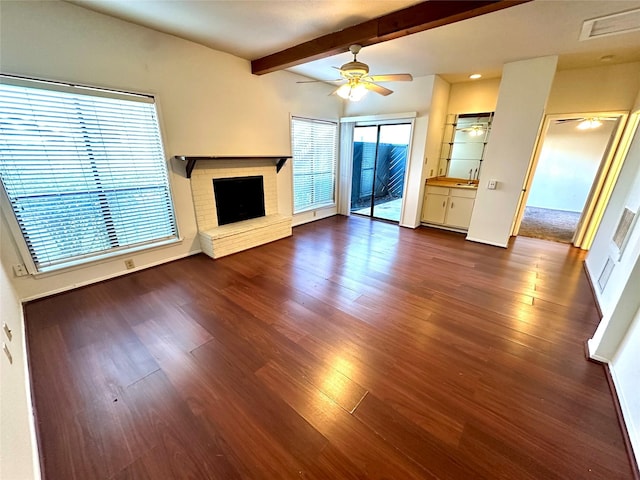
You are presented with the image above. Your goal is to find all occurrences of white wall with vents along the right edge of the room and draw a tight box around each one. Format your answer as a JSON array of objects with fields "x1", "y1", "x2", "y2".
[{"x1": 585, "y1": 81, "x2": 640, "y2": 468}]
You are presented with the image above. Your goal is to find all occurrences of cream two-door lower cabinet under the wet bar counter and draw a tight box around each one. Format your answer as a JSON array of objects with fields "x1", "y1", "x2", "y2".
[{"x1": 422, "y1": 185, "x2": 476, "y2": 230}]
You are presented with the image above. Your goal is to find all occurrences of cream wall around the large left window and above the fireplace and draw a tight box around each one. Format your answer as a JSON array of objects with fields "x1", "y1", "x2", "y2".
[{"x1": 0, "y1": 1, "x2": 342, "y2": 299}]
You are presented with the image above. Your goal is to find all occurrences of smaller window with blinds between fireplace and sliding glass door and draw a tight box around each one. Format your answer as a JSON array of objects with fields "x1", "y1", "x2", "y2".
[{"x1": 291, "y1": 117, "x2": 338, "y2": 213}]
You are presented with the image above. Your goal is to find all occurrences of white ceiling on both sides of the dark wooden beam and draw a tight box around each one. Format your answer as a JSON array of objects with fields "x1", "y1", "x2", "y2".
[{"x1": 68, "y1": 0, "x2": 640, "y2": 82}]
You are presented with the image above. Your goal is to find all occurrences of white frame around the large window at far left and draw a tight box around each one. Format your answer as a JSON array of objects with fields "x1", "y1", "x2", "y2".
[{"x1": 0, "y1": 74, "x2": 183, "y2": 277}]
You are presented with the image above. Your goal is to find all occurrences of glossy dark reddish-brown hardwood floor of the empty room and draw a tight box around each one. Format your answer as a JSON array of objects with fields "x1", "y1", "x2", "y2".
[{"x1": 26, "y1": 217, "x2": 633, "y2": 480}]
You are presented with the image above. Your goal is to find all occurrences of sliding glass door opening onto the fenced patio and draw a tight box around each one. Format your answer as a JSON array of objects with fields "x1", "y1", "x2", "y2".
[{"x1": 350, "y1": 123, "x2": 412, "y2": 223}]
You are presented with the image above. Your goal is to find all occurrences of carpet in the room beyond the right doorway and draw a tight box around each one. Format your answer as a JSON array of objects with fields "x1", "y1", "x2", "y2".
[{"x1": 518, "y1": 207, "x2": 581, "y2": 243}]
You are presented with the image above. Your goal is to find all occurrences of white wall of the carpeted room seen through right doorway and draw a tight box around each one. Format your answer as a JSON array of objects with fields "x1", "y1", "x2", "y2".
[{"x1": 527, "y1": 121, "x2": 616, "y2": 212}]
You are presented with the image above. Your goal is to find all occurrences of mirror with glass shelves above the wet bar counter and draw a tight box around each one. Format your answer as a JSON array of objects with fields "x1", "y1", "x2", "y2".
[{"x1": 438, "y1": 112, "x2": 493, "y2": 180}]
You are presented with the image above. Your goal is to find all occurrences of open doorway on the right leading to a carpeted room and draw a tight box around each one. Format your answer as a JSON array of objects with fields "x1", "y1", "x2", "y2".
[{"x1": 515, "y1": 113, "x2": 626, "y2": 249}]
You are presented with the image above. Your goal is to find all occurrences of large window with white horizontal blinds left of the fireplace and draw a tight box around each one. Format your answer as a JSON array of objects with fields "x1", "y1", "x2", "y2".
[{"x1": 0, "y1": 76, "x2": 178, "y2": 272}]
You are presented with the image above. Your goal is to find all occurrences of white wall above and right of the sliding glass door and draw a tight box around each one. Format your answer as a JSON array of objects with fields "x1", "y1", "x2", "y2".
[{"x1": 344, "y1": 75, "x2": 436, "y2": 228}]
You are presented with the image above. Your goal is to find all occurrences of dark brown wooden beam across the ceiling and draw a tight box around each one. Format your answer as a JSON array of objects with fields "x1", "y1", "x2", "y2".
[{"x1": 251, "y1": 0, "x2": 531, "y2": 75}]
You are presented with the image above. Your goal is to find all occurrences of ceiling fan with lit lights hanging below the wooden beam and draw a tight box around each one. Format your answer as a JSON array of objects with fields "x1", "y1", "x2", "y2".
[{"x1": 298, "y1": 45, "x2": 413, "y2": 102}]
